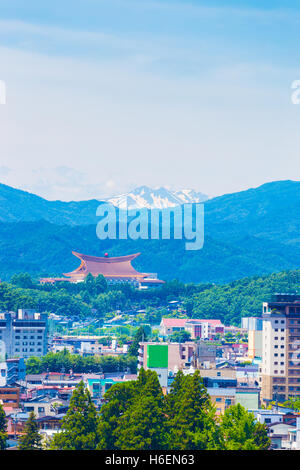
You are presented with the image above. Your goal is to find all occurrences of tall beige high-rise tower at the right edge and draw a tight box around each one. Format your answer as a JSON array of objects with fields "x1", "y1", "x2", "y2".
[{"x1": 260, "y1": 294, "x2": 300, "y2": 402}]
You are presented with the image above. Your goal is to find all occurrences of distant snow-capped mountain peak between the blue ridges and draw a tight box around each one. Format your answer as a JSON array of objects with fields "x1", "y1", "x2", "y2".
[{"x1": 106, "y1": 186, "x2": 209, "y2": 210}]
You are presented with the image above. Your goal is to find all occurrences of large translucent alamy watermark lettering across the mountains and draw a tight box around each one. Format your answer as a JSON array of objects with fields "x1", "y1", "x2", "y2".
[{"x1": 96, "y1": 203, "x2": 204, "y2": 250}]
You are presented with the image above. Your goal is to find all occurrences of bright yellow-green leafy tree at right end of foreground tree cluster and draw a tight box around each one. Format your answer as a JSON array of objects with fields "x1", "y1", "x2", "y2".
[{"x1": 220, "y1": 403, "x2": 270, "y2": 450}]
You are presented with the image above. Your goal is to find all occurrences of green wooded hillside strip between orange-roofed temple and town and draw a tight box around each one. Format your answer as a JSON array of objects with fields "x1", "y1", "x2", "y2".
[{"x1": 0, "y1": 270, "x2": 300, "y2": 325}]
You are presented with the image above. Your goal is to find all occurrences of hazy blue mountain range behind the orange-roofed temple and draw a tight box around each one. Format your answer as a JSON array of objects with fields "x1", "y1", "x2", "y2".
[{"x1": 0, "y1": 180, "x2": 300, "y2": 283}]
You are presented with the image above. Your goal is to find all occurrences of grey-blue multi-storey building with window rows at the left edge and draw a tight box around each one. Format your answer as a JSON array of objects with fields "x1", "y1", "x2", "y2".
[{"x1": 0, "y1": 309, "x2": 47, "y2": 359}]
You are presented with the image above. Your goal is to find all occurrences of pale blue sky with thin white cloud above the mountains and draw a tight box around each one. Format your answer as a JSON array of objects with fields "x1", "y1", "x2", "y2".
[{"x1": 0, "y1": 0, "x2": 300, "y2": 201}]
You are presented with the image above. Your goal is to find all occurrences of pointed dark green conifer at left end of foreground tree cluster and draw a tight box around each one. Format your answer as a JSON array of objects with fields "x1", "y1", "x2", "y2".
[{"x1": 50, "y1": 381, "x2": 98, "y2": 450}]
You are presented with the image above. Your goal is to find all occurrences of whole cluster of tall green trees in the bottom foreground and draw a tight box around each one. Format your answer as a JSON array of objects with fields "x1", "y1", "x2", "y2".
[{"x1": 49, "y1": 369, "x2": 270, "y2": 450}]
